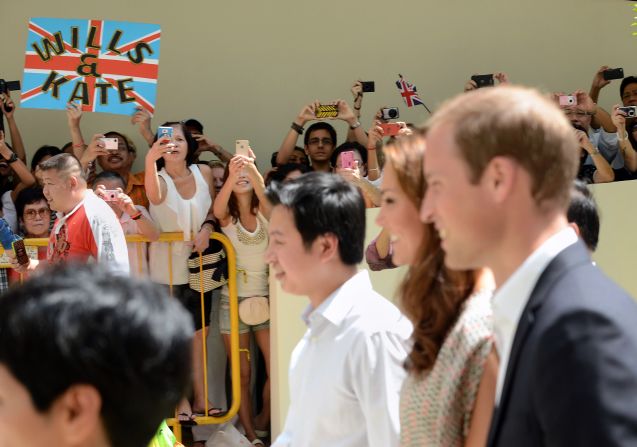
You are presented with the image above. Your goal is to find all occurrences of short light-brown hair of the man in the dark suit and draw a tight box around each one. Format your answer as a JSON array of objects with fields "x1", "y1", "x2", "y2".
[{"x1": 427, "y1": 86, "x2": 580, "y2": 209}]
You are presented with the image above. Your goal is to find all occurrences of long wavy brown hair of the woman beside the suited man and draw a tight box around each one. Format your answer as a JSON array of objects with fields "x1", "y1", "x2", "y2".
[{"x1": 385, "y1": 135, "x2": 475, "y2": 375}]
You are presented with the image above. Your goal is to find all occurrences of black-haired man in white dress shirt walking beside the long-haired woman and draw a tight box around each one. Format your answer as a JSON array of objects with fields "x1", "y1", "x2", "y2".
[{"x1": 266, "y1": 173, "x2": 412, "y2": 447}]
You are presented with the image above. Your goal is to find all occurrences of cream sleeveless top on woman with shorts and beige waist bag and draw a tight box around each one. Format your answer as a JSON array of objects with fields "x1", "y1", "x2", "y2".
[{"x1": 221, "y1": 213, "x2": 270, "y2": 297}]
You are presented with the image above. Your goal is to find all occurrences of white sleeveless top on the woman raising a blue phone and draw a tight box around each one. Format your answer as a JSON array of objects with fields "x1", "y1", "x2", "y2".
[{"x1": 148, "y1": 164, "x2": 212, "y2": 284}]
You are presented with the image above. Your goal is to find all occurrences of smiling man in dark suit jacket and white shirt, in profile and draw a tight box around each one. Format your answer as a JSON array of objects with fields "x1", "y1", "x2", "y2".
[{"x1": 421, "y1": 87, "x2": 637, "y2": 447}]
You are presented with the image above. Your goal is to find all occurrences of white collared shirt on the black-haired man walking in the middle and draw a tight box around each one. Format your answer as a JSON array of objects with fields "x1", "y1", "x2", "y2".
[{"x1": 272, "y1": 270, "x2": 412, "y2": 447}]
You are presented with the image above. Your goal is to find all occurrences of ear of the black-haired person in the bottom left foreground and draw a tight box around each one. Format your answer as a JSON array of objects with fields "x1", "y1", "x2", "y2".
[{"x1": 51, "y1": 384, "x2": 103, "y2": 446}]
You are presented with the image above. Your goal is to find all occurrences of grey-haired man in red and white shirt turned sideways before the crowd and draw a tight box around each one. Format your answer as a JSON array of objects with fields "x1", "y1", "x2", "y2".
[{"x1": 14, "y1": 154, "x2": 130, "y2": 274}]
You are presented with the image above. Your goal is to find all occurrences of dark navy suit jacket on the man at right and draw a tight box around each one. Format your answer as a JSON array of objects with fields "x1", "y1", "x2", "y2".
[{"x1": 488, "y1": 242, "x2": 637, "y2": 447}]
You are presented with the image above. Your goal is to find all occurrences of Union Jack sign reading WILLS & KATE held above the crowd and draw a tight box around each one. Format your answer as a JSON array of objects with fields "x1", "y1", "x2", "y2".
[{"x1": 20, "y1": 18, "x2": 161, "y2": 115}]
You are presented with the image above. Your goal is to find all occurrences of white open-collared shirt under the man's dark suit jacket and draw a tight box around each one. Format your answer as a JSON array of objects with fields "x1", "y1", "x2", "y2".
[{"x1": 493, "y1": 227, "x2": 577, "y2": 405}]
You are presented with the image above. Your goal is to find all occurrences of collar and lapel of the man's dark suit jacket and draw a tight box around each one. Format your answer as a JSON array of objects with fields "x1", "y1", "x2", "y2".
[{"x1": 487, "y1": 242, "x2": 591, "y2": 446}]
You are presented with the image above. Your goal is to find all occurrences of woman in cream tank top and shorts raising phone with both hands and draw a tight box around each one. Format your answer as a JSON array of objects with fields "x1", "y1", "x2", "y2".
[{"x1": 214, "y1": 150, "x2": 271, "y2": 445}]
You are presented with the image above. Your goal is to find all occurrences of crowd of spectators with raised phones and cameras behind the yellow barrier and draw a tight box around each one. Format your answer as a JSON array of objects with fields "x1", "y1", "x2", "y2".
[{"x1": 0, "y1": 66, "x2": 637, "y2": 444}]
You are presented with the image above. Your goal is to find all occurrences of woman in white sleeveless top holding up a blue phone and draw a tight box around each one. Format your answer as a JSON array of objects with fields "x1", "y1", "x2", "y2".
[{"x1": 145, "y1": 123, "x2": 214, "y2": 424}]
